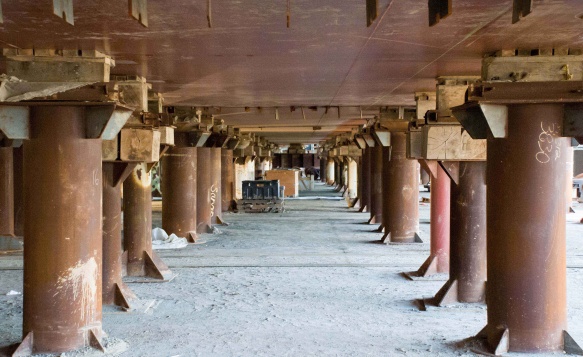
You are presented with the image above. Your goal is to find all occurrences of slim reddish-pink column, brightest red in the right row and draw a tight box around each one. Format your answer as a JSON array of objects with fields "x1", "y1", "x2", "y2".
[{"x1": 415, "y1": 162, "x2": 452, "y2": 277}]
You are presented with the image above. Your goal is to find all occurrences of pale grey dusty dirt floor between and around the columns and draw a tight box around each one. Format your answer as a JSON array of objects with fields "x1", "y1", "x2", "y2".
[{"x1": 0, "y1": 184, "x2": 583, "y2": 357}]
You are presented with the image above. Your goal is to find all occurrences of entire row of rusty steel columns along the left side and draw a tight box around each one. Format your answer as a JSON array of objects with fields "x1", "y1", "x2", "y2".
[{"x1": 0, "y1": 109, "x2": 240, "y2": 355}]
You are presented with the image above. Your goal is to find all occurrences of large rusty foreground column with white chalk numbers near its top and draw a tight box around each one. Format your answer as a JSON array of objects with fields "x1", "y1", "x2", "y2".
[{"x1": 480, "y1": 104, "x2": 570, "y2": 353}]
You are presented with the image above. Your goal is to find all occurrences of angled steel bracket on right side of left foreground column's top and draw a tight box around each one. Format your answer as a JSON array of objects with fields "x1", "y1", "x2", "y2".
[{"x1": 85, "y1": 104, "x2": 133, "y2": 140}]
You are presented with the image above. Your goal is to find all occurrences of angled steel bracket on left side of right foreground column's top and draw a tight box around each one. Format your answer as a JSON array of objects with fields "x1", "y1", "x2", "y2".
[{"x1": 451, "y1": 102, "x2": 508, "y2": 139}]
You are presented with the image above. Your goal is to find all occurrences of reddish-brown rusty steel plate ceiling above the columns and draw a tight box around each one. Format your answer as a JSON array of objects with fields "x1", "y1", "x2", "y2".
[{"x1": 0, "y1": 0, "x2": 583, "y2": 144}]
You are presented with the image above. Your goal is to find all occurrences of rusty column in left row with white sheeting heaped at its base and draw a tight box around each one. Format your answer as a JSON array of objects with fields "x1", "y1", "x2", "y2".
[{"x1": 162, "y1": 138, "x2": 197, "y2": 243}]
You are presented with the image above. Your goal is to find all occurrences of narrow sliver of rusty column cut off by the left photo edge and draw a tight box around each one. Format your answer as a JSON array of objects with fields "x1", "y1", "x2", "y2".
[{"x1": 0, "y1": 147, "x2": 14, "y2": 236}]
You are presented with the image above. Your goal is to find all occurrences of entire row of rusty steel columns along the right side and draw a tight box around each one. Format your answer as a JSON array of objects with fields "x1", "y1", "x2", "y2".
[{"x1": 327, "y1": 104, "x2": 583, "y2": 354}]
